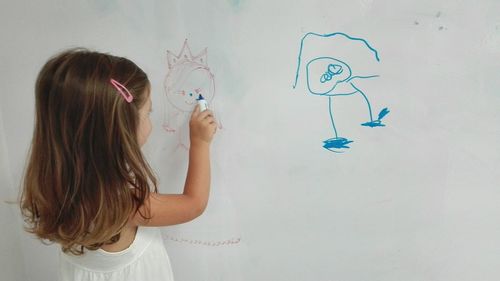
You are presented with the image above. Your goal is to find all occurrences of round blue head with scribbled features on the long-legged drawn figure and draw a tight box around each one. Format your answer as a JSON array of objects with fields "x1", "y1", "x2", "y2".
[{"x1": 306, "y1": 57, "x2": 351, "y2": 95}]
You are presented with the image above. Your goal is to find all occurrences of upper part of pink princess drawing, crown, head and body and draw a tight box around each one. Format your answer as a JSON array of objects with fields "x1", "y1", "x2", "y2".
[{"x1": 163, "y1": 39, "x2": 216, "y2": 150}]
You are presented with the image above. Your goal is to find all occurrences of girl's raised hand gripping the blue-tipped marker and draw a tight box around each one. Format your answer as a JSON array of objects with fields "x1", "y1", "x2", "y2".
[{"x1": 189, "y1": 105, "x2": 217, "y2": 145}]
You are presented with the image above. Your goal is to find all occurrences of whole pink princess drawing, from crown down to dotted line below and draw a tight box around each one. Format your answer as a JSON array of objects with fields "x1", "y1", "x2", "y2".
[{"x1": 162, "y1": 39, "x2": 241, "y2": 247}]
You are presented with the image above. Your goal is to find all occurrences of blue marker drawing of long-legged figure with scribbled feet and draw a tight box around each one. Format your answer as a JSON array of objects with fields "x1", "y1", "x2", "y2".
[{"x1": 293, "y1": 32, "x2": 389, "y2": 152}]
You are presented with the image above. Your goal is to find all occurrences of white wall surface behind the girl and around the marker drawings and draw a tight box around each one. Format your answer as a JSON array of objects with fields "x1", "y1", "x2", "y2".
[{"x1": 0, "y1": 0, "x2": 500, "y2": 281}]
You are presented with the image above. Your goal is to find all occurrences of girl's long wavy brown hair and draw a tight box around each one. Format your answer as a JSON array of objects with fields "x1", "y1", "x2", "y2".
[{"x1": 21, "y1": 49, "x2": 157, "y2": 254}]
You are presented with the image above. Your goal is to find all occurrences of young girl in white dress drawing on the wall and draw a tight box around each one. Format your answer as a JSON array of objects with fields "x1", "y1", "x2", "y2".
[{"x1": 21, "y1": 49, "x2": 217, "y2": 281}]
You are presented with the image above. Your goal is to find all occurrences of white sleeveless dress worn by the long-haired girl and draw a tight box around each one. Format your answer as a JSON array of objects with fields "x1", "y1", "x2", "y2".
[{"x1": 59, "y1": 227, "x2": 174, "y2": 281}]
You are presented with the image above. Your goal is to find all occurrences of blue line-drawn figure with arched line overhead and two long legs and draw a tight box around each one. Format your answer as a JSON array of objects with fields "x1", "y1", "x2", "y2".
[{"x1": 293, "y1": 32, "x2": 389, "y2": 153}]
